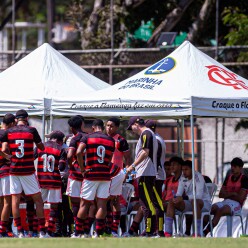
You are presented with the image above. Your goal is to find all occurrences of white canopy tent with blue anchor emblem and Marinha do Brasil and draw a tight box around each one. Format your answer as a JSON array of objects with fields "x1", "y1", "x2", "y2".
[{"x1": 52, "y1": 41, "x2": 248, "y2": 235}]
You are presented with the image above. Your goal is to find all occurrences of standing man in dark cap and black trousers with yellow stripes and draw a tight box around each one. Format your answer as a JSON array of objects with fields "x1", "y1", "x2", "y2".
[{"x1": 127, "y1": 116, "x2": 158, "y2": 237}]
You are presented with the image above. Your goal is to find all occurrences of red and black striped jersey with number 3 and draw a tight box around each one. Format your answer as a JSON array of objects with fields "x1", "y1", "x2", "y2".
[{"x1": 1, "y1": 125, "x2": 41, "y2": 176}]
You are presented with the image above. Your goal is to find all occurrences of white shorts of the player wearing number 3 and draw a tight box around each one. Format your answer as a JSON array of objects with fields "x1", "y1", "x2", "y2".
[{"x1": 10, "y1": 174, "x2": 40, "y2": 195}]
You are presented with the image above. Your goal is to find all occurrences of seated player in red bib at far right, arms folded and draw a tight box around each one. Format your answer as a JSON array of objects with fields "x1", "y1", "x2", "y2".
[{"x1": 204, "y1": 157, "x2": 248, "y2": 235}]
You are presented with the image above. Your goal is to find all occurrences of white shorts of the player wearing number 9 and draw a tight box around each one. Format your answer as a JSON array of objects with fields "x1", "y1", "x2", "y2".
[{"x1": 80, "y1": 179, "x2": 110, "y2": 201}]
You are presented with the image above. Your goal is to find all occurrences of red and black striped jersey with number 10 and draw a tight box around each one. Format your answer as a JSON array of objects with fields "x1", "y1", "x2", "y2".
[{"x1": 34, "y1": 140, "x2": 66, "y2": 189}]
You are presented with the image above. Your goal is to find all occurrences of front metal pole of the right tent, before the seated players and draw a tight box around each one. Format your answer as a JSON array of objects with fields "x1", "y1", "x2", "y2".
[{"x1": 190, "y1": 114, "x2": 197, "y2": 237}]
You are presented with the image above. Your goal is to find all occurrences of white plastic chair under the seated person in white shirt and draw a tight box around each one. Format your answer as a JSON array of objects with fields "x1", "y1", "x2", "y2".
[{"x1": 179, "y1": 183, "x2": 217, "y2": 237}]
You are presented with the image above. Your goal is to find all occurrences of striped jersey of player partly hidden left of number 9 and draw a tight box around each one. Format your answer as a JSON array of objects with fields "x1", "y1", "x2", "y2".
[{"x1": 69, "y1": 132, "x2": 87, "y2": 181}]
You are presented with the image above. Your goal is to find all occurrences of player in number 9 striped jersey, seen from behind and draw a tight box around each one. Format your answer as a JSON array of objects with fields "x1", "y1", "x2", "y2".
[{"x1": 75, "y1": 119, "x2": 115, "y2": 238}]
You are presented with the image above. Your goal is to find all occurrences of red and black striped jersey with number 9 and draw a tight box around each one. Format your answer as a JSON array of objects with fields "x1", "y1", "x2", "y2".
[{"x1": 81, "y1": 132, "x2": 115, "y2": 181}]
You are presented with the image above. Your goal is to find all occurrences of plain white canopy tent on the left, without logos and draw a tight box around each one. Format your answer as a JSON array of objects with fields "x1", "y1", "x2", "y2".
[{"x1": 0, "y1": 43, "x2": 109, "y2": 138}]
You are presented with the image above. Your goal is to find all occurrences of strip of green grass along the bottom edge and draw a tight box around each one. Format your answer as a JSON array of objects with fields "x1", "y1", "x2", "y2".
[{"x1": 0, "y1": 238, "x2": 248, "y2": 248}]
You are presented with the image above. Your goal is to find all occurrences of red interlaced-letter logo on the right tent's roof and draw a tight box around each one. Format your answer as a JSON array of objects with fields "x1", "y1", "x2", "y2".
[{"x1": 206, "y1": 65, "x2": 248, "y2": 90}]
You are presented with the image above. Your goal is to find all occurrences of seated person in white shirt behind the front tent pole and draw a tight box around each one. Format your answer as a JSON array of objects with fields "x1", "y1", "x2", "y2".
[{"x1": 165, "y1": 160, "x2": 211, "y2": 237}]
